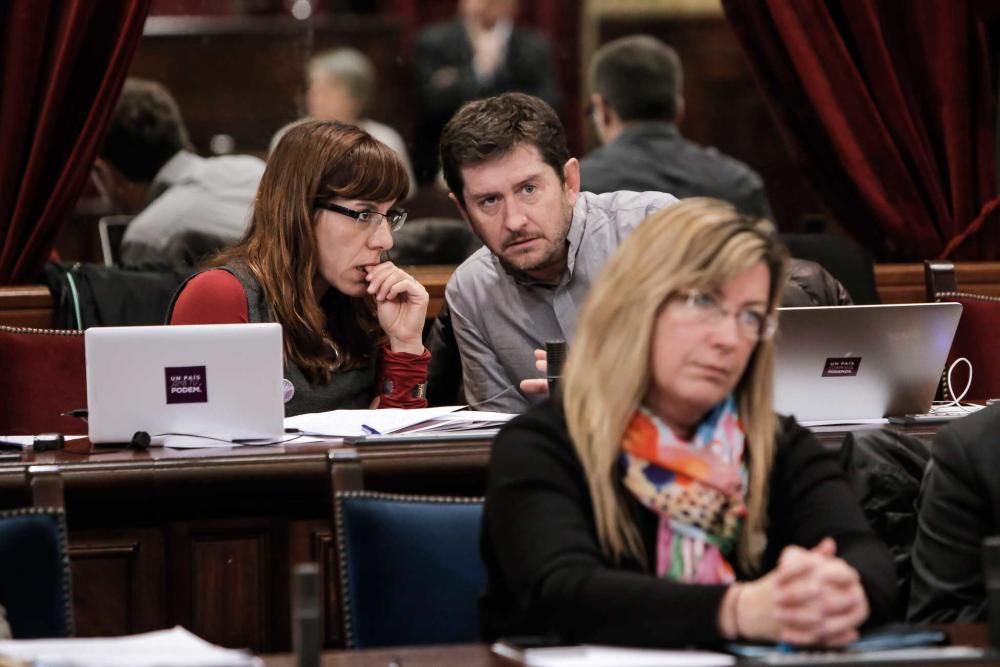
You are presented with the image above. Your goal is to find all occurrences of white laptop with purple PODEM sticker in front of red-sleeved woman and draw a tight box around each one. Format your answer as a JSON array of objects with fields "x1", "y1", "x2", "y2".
[{"x1": 84, "y1": 324, "x2": 285, "y2": 443}]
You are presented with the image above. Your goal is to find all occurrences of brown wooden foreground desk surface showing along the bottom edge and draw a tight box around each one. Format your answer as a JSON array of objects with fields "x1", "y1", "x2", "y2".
[{"x1": 264, "y1": 623, "x2": 998, "y2": 667}]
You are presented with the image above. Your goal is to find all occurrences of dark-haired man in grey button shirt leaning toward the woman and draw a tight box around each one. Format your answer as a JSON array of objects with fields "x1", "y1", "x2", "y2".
[{"x1": 441, "y1": 93, "x2": 676, "y2": 412}]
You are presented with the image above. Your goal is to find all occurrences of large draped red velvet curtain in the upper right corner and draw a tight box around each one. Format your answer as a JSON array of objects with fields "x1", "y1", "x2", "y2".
[{"x1": 723, "y1": 0, "x2": 1000, "y2": 261}]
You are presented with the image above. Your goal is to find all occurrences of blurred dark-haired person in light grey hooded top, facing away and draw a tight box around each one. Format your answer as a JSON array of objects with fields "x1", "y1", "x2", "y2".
[{"x1": 94, "y1": 78, "x2": 264, "y2": 266}]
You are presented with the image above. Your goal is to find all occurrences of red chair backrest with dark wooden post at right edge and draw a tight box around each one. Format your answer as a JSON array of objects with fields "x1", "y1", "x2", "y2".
[{"x1": 924, "y1": 261, "x2": 1000, "y2": 400}]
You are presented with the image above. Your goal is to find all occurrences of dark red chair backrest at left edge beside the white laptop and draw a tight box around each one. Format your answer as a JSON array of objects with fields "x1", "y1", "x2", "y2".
[{"x1": 0, "y1": 326, "x2": 87, "y2": 435}]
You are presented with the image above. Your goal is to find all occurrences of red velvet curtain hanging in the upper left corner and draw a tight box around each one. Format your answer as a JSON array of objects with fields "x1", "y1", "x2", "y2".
[{"x1": 0, "y1": 0, "x2": 149, "y2": 285}]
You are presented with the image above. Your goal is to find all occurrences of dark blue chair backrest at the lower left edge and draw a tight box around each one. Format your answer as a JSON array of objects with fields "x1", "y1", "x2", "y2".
[{"x1": 0, "y1": 508, "x2": 73, "y2": 639}]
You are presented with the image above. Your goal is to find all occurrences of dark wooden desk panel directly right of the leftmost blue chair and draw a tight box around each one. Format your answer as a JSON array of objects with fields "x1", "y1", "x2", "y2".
[{"x1": 69, "y1": 529, "x2": 168, "y2": 637}]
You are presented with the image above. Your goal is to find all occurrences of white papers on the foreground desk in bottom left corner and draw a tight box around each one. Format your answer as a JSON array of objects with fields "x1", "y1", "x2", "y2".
[{"x1": 0, "y1": 626, "x2": 263, "y2": 667}]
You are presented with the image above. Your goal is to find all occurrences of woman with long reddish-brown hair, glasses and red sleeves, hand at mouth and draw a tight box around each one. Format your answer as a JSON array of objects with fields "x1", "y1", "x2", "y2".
[{"x1": 168, "y1": 121, "x2": 430, "y2": 416}]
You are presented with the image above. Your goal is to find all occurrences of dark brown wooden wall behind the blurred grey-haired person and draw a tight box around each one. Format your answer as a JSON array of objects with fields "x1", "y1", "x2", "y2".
[{"x1": 129, "y1": 15, "x2": 409, "y2": 155}]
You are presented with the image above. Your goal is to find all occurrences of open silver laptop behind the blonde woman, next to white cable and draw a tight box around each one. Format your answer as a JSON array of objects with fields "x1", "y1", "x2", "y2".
[{"x1": 774, "y1": 303, "x2": 962, "y2": 422}]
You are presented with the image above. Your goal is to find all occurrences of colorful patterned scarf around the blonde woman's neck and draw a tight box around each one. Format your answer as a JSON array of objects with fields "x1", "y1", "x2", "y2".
[{"x1": 622, "y1": 396, "x2": 747, "y2": 584}]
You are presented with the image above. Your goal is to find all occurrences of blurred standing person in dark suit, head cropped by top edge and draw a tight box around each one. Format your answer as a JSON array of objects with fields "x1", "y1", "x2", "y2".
[{"x1": 413, "y1": 0, "x2": 557, "y2": 183}]
